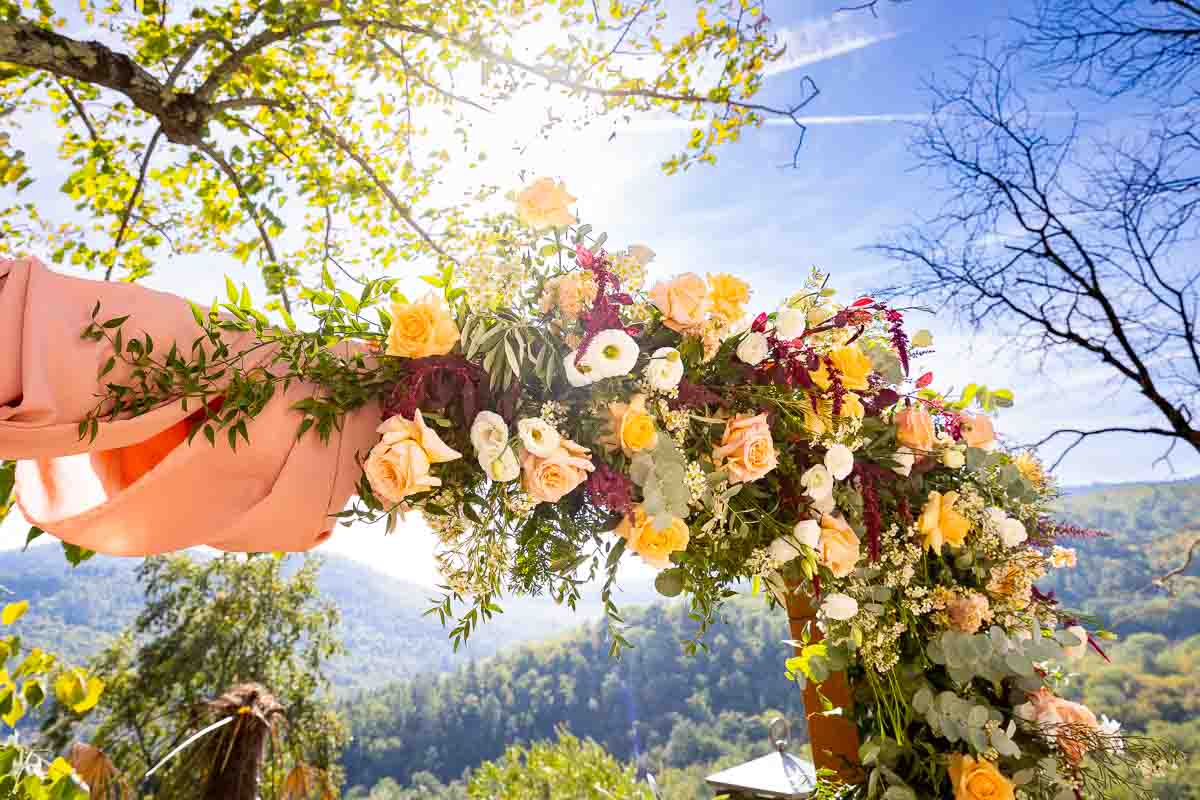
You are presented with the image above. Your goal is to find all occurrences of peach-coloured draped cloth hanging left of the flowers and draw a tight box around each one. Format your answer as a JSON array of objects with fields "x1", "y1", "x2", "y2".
[{"x1": 0, "y1": 258, "x2": 379, "y2": 555}]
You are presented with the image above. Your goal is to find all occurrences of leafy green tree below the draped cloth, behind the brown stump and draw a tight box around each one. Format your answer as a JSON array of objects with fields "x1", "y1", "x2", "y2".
[{"x1": 43, "y1": 555, "x2": 346, "y2": 798}]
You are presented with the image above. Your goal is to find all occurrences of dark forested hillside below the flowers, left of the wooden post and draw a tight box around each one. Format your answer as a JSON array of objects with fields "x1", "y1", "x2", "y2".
[{"x1": 343, "y1": 597, "x2": 802, "y2": 787}]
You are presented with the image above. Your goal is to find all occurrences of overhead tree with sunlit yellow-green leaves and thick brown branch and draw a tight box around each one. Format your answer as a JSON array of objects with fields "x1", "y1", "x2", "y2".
[{"x1": 0, "y1": 0, "x2": 816, "y2": 308}]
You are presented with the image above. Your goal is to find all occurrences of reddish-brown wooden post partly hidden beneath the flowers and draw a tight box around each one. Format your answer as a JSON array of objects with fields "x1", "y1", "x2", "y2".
[{"x1": 787, "y1": 587, "x2": 863, "y2": 783}]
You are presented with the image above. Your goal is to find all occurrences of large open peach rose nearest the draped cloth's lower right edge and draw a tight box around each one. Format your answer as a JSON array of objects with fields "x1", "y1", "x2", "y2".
[{"x1": 364, "y1": 410, "x2": 462, "y2": 504}]
